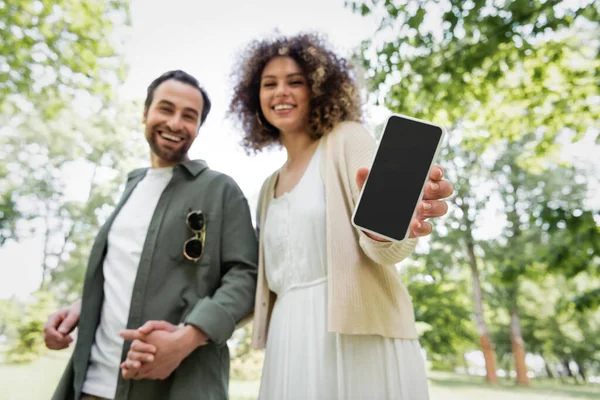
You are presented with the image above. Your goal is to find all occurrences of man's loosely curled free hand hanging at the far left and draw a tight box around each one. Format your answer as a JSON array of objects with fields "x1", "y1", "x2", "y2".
[{"x1": 44, "y1": 300, "x2": 81, "y2": 350}]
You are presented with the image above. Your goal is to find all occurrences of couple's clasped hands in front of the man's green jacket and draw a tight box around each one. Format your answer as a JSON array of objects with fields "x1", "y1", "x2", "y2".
[{"x1": 120, "y1": 321, "x2": 208, "y2": 380}]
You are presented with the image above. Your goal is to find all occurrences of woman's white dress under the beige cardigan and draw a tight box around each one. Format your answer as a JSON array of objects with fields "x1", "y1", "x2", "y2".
[{"x1": 259, "y1": 145, "x2": 429, "y2": 400}]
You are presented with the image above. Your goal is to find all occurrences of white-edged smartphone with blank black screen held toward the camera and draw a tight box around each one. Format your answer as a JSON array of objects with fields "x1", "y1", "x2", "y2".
[{"x1": 352, "y1": 114, "x2": 446, "y2": 241}]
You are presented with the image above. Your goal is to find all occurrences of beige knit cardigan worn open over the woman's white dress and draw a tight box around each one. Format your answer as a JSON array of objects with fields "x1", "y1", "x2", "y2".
[{"x1": 252, "y1": 122, "x2": 417, "y2": 348}]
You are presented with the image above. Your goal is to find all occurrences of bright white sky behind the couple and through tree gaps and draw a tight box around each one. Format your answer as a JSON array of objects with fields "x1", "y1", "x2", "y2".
[{"x1": 0, "y1": 0, "x2": 600, "y2": 298}]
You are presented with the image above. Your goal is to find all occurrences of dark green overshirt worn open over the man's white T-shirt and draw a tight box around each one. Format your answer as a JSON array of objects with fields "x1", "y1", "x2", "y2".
[{"x1": 53, "y1": 161, "x2": 258, "y2": 400}]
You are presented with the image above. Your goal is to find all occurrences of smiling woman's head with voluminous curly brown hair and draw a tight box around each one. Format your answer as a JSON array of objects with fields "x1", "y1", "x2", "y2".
[{"x1": 229, "y1": 35, "x2": 361, "y2": 152}]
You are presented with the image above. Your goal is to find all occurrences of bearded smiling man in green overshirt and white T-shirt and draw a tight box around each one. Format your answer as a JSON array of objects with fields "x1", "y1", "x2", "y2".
[{"x1": 44, "y1": 71, "x2": 258, "y2": 400}]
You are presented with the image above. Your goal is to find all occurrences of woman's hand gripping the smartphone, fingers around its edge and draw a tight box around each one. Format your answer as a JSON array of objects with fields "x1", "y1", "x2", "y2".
[{"x1": 356, "y1": 164, "x2": 454, "y2": 242}]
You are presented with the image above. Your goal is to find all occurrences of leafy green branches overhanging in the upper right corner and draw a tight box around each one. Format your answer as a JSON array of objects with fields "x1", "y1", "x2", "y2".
[{"x1": 348, "y1": 0, "x2": 600, "y2": 147}]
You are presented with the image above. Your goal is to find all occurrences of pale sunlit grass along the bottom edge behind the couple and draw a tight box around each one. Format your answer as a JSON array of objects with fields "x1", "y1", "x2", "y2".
[{"x1": 0, "y1": 350, "x2": 600, "y2": 400}]
